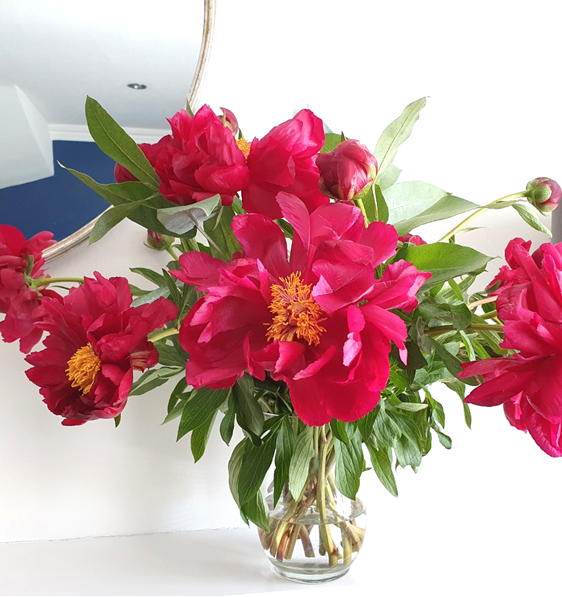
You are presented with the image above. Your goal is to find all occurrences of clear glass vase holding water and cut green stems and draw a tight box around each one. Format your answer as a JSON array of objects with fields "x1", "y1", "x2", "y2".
[{"x1": 258, "y1": 426, "x2": 366, "y2": 583}]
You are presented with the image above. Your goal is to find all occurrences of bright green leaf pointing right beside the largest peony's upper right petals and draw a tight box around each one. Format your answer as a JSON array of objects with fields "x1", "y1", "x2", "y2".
[{"x1": 400, "y1": 243, "x2": 491, "y2": 288}]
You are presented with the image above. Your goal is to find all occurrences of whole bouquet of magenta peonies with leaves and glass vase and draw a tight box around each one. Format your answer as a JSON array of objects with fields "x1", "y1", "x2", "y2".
[{"x1": 0, "y1": 98, "x2": 562, "y2": 580}]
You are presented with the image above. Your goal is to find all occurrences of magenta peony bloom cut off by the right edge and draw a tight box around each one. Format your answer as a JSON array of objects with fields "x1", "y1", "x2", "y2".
[{"x1": 460, "y1": 239, "x2": 562, "y2": 456}]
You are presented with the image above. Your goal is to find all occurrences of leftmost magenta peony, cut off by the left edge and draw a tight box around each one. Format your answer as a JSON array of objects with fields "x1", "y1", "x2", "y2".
[{"x1": 0, "y1": 224, "x2": 58, "y2": 353}]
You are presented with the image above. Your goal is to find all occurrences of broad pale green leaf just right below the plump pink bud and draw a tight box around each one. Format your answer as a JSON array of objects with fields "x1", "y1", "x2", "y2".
[{"x1": 384, "y1": 180, "x2": 447, "y2": 224}]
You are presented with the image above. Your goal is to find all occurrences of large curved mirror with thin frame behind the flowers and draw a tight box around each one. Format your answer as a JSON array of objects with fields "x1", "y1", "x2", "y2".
[{"x1": 0, "y1": 0, "x2": 214, "y2": 256}]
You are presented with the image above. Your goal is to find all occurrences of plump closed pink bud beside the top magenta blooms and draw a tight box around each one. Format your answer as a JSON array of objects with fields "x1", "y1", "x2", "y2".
[{"x1": 316, "y1": 139, "x2": 377, "y2": 201}]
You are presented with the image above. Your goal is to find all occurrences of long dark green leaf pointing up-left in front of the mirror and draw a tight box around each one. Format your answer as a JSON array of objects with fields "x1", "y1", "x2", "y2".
[{"x1": 86, "y1": 97, "x2": 160, "y2": 188}]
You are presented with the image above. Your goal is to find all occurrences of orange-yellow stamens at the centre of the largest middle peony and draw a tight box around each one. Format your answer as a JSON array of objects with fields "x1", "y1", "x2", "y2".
[{"x1": 267, "y1": 272, "x2": 326, "y2": 346}]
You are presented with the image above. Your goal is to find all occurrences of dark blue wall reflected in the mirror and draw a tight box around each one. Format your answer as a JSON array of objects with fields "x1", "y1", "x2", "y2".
[{"x1": 0, "y1": 141, "x2": 115, "y2": 240}]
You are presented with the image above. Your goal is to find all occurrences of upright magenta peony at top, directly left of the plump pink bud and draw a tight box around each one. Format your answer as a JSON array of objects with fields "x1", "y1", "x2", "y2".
[{"x1": 242, "y1": 110, "x2": 328, "y2": 219}]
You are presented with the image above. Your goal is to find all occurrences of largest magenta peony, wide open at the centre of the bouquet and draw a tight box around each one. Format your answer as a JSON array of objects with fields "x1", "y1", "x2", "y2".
[{"x1": 172, "y1": 193, "x2": 430, "y2": 425}]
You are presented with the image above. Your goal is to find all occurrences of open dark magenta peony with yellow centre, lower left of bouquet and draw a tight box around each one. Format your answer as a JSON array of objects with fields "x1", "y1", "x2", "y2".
[{"x1": 26, "y1": 272, "x2": 177, "y2": 425}]
